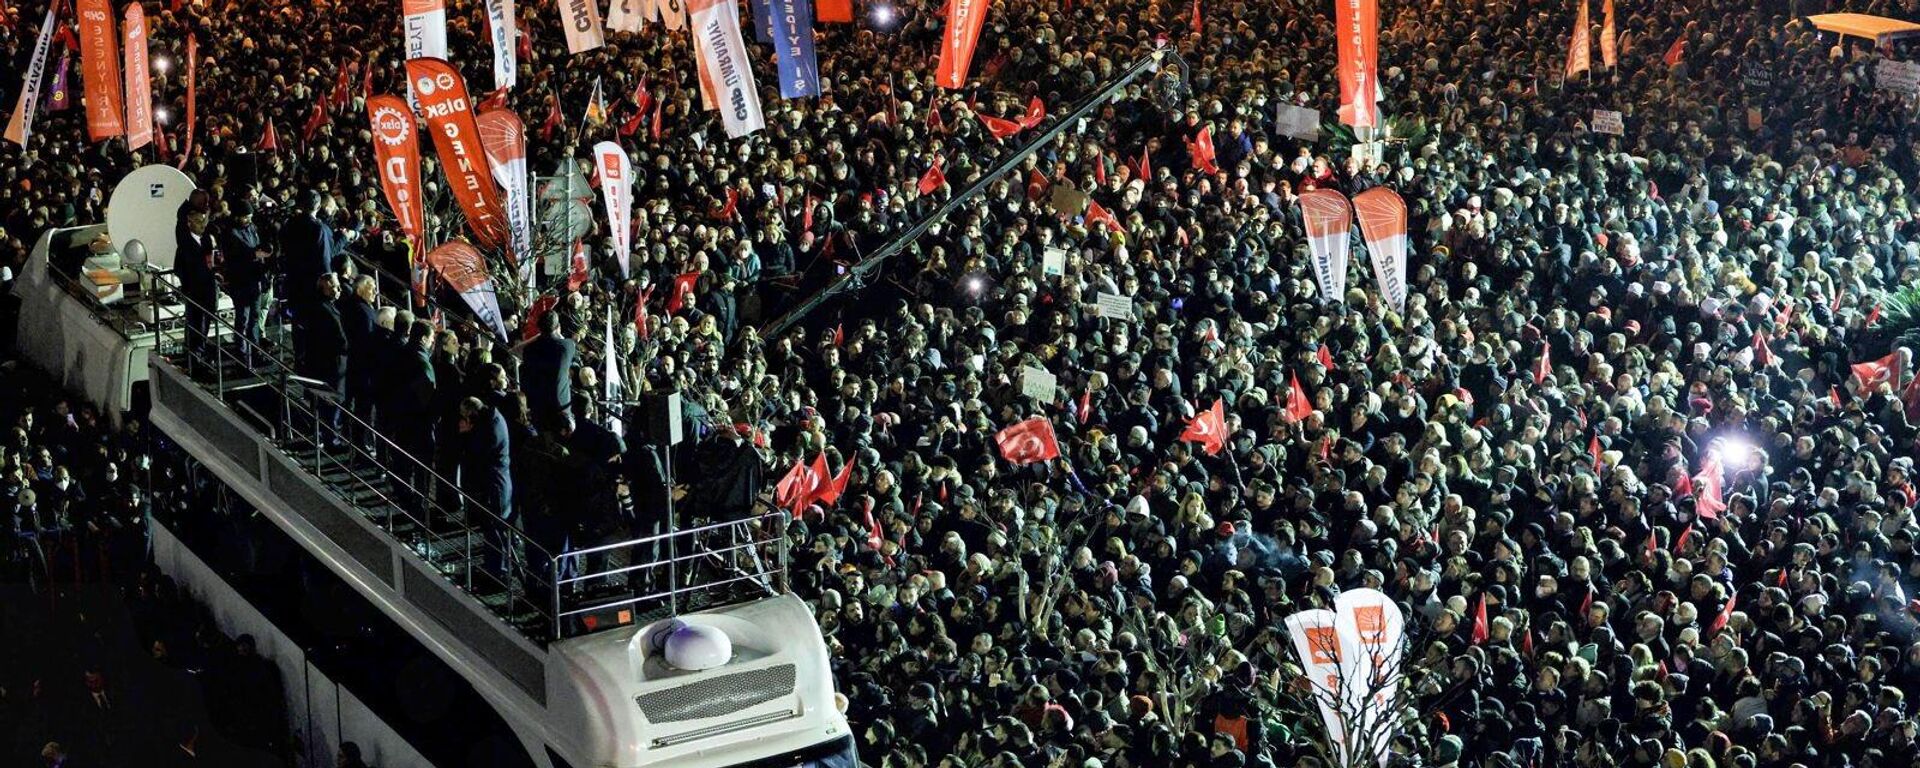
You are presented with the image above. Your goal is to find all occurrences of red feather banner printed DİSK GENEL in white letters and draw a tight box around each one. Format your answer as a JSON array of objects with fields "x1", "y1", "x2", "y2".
[{"x1": 407, "y1": 60, "x2": 507, "y2": 248}]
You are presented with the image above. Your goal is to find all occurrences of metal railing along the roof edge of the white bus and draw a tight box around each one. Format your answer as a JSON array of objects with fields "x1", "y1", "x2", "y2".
[{"x1": 142, "y1": 275, "x2": 789, "y2": 643}]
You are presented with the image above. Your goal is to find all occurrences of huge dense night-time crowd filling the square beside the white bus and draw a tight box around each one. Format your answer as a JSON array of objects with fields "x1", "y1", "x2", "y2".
[{"x1": 11, "y1": 0, "x2": 1920, "y2": 768}]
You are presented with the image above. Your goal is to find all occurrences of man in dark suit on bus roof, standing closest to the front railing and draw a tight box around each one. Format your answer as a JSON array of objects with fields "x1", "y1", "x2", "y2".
[{"x1": 457, "y1": 397, "x2": 520, "y2": 589}]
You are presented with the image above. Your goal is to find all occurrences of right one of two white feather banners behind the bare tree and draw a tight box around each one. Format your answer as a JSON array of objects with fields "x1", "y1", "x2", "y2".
[{"x1": 1332, "y1": 589, "x2": 1405, "y2": 766}]
